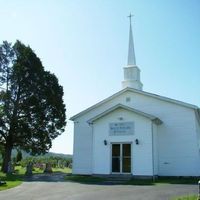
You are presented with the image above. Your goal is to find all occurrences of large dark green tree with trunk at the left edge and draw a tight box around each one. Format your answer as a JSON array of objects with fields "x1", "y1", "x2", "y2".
[{"x1": 0, "y1": 41, "x2": 66, "y2": 172}]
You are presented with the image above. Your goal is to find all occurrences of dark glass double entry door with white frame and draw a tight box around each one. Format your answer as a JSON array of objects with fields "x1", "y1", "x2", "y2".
[{"x1": 111, "y1": 143, "x2": 131, "y2": 173}]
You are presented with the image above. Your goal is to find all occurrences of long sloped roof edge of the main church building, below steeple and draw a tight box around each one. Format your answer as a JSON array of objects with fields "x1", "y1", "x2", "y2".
[{"x1": 70, "y1": 87, "x2": 200, "y2": 121}]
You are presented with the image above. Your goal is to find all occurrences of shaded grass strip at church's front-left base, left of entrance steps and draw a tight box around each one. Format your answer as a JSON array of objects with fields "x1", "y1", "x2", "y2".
[{"x1": 65, "y1": 175, "x2": 105, "y2": 184}]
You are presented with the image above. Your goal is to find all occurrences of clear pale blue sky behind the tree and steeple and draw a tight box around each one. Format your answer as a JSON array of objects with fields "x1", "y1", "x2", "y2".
[{"x1": 0, "y1": 0, "x2": 200, "y2": 154}]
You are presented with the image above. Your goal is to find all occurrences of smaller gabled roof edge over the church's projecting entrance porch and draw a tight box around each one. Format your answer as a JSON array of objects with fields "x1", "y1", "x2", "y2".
[{"x1": 88, "y1": 104, "x2": 162, "y2": 124}]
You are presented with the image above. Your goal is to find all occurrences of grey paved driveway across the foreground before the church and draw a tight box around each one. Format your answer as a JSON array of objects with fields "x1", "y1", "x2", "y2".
[{"x1": 0, "y1": 175, "x2": 197, "y2": 200}]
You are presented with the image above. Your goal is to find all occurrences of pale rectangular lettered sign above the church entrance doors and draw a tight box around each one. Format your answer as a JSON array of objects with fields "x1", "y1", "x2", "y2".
[{"x1": 109, "y1": 122, "x2": 134, "y2": 135}]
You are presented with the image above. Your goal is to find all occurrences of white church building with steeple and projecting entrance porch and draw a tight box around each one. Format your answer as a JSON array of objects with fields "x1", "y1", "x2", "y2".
[{"x1": 71, "y1": 18, "x2": 200, "y2": 177}]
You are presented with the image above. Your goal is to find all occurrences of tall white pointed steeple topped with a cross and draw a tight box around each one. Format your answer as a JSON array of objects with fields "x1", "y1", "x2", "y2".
[{"x1": 122, "y1": 14, "x2": 143, "y2": 90}]
